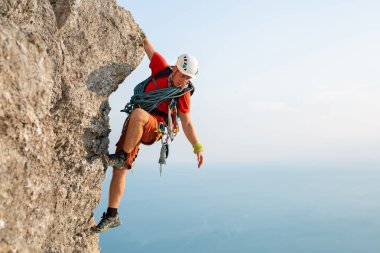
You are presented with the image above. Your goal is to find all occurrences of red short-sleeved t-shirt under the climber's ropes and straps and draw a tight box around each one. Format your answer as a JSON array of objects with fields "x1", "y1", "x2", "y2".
[{"x1": 145, "y1": 52, "x2": 190, "y2": 122}]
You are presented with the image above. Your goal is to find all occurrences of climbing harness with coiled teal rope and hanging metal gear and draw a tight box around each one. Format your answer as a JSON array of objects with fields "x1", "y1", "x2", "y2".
[{"x1": 121, "y1": 67, "x2": 194, "y2": 176}]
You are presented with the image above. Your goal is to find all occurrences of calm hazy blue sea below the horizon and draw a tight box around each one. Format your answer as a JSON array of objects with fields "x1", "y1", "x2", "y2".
[{"x1": 95, "y1": 166, "x2": 380, "y2": 253}]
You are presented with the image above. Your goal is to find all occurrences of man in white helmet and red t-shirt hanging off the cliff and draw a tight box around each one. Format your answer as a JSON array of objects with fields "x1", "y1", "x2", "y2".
[{"x1": 92, "y1": 38, "x2": 203, "y2": 233}]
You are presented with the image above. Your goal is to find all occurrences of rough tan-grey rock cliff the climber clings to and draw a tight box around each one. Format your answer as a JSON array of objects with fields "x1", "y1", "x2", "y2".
[{"x1": 0, "y1": 0, "x2": 144, "y2": 252}]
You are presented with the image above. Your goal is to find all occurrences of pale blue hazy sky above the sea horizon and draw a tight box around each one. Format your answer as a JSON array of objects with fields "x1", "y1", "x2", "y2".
[{"x1": 110, "y1": 0, "x2": 380, "y2": 168}]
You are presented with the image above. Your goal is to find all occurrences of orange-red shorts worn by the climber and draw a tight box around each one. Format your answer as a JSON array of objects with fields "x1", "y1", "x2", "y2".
[{"x1": 115, "y1": 115, "x2": 161, "y2": 170}]
